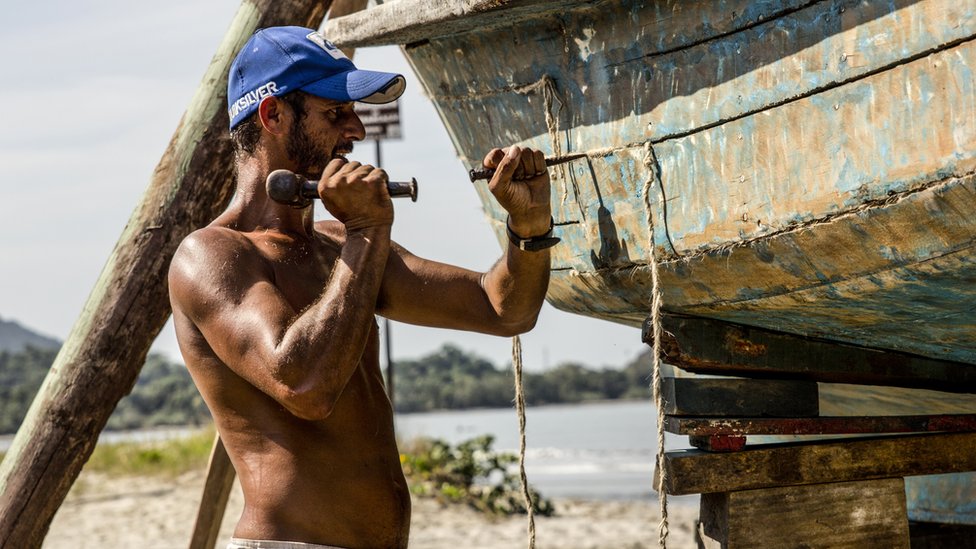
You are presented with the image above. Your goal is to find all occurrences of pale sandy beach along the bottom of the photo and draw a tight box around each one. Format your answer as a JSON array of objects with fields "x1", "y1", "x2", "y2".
[{"x1": 43, "y1": 471, "x2": 698, "y2": 549}]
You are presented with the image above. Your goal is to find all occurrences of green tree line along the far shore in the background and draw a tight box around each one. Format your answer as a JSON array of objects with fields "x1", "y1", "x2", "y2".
[{"x1": 0, "y1": 345, "x2": 650, "y2": 434}]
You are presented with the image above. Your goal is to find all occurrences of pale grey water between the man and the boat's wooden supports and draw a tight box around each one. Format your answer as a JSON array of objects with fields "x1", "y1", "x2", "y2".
[{"x1": 396, "y1": 400, "x2": 697, "y2": 504}]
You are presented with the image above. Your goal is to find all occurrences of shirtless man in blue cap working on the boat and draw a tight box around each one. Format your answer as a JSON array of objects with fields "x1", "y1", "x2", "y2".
[{"x1": 169, "y1": 27, "x2": 552, "y2": 549}]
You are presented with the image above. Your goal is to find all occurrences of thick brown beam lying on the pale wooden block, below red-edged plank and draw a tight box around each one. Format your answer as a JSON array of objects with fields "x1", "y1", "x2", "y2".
[{"x1": 664, "y1": 433, "x2": 976, "y2": 495}]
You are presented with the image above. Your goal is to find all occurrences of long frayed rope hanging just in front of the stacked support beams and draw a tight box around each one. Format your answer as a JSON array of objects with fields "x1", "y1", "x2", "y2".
[{"x1": 644, "y1": 141, "x2": 668, "y2": 549}]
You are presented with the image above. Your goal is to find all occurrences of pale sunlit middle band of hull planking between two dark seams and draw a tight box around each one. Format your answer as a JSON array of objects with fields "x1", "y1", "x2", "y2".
[{"x1": 504, "y1": 33, "x2": 976, "y2": 266}]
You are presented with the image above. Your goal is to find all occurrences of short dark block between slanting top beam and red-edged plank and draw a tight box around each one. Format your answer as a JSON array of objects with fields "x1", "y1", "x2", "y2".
[{"x1": 661, "y1": 377, "x2": 820, "y2": 417}]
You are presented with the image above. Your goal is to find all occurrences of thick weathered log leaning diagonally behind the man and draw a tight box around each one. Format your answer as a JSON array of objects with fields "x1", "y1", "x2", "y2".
[{"x1": 0, "y1": 0, "x2": 331, "y2": 549}]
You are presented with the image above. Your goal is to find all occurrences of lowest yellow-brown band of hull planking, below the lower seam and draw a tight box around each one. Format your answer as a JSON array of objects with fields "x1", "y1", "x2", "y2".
[{"x1": 549, "y1": 173, "x2": 976, "y2": 363}]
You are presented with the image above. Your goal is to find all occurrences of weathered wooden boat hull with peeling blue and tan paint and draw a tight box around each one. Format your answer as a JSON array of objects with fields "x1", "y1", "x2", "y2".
[{"x1": 326, "y1": 0, "x2": 976, "y2": 523}]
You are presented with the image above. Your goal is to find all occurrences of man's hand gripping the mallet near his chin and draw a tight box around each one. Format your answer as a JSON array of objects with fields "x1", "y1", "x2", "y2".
[{"x1": 318, "y1": 158, "x2": 393, "y2": 231}]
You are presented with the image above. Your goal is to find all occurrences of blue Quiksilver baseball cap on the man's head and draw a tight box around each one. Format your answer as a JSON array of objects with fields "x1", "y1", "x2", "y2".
[{"x1": 227, "y1": 27, "x2": 407, "y2": 129}]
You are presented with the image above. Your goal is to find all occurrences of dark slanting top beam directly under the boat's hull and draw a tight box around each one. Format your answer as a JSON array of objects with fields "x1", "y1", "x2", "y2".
[{"x1": 643, "y1": 314, "x2": 976, "y2": 393}]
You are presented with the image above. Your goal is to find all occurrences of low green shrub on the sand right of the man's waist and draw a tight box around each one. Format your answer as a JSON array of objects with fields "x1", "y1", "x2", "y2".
[{"x1": 400, "y1": 435, "x2": 555, "y2": 516}]
